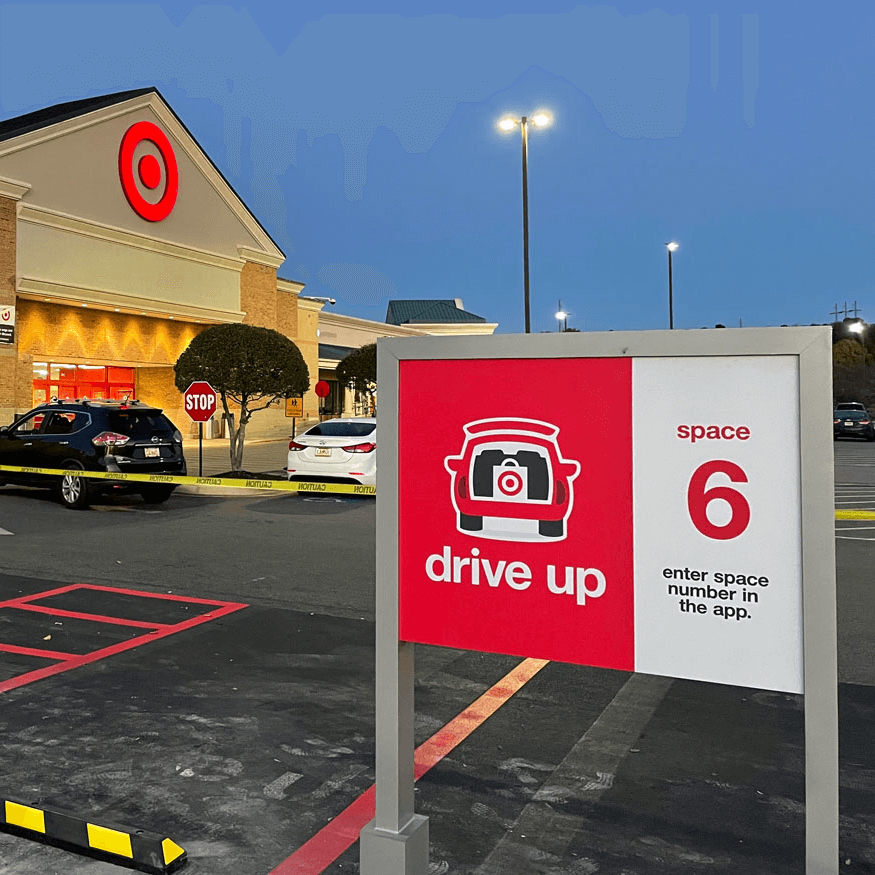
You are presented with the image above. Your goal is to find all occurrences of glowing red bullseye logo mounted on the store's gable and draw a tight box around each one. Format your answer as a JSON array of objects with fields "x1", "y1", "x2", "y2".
[{"x1": 118, "y1": 122, "x2": 179, "y2": 222}]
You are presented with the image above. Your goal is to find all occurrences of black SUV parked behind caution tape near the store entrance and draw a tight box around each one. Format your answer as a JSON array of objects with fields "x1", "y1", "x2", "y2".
[{"x1": 0, "y1": 399, "x2": 186, "y2": 508}]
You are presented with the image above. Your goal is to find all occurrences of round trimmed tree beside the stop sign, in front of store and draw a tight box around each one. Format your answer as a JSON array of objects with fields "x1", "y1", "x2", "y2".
[{"x1": 173, "y1": 324, "x2": 310, "y2": 471}]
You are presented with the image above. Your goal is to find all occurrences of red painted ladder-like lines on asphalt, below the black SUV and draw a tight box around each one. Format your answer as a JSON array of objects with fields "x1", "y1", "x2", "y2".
[{"x1": 0, "y1": 583, "x2": 247, "y2": 693}]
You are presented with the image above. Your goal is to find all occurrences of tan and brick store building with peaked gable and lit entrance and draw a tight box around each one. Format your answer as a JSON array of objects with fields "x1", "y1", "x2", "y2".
[{"x1": 0, "y1": 88, "x2": 323, "y2": 436}]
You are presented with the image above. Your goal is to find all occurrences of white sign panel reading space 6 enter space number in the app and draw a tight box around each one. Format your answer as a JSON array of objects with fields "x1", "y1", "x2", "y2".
[{"x1": 632, "y1": 356, "x2": 803, "y2": 692}]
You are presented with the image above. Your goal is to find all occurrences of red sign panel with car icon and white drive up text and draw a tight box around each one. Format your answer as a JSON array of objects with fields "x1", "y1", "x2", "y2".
[{"x1": 398, "y1": 358, "x2": 635, "y2": 671}]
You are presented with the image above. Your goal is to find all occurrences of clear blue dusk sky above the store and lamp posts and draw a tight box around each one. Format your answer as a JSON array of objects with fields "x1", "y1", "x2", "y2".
[{"x1": 0, "y1": 0, "x2": 875, "y2": 333}]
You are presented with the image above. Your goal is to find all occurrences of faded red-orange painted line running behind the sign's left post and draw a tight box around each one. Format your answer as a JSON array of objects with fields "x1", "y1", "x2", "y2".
[{"x1": 270, "y1": 659, "x2": 548, "y2": 875}]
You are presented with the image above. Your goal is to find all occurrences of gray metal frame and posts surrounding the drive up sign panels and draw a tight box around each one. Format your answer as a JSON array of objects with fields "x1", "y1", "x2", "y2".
[{"x1": 360, "y1": 326, "x2": 839, "y2": 875}]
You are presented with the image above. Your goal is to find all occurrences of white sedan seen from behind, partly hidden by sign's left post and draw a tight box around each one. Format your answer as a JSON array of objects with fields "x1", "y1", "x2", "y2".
[{"x1": 286, "y1": 416, "x2": 377, "y2": 486}]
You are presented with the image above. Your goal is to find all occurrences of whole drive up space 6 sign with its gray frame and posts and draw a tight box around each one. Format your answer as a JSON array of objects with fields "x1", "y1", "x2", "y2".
[{"x1": 362, "y1": 327, "x2": 838, "y2": 875}]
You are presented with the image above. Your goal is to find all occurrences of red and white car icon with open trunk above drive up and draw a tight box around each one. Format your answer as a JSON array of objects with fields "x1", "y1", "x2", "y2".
[{"x1": 444, "y1": 418, "x2": 580, "y2": 541}]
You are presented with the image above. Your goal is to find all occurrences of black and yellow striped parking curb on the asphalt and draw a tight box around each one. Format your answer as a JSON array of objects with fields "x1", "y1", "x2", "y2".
[{"x1": 0, "y1": 798, "x2": 187, "y2": 875}]
